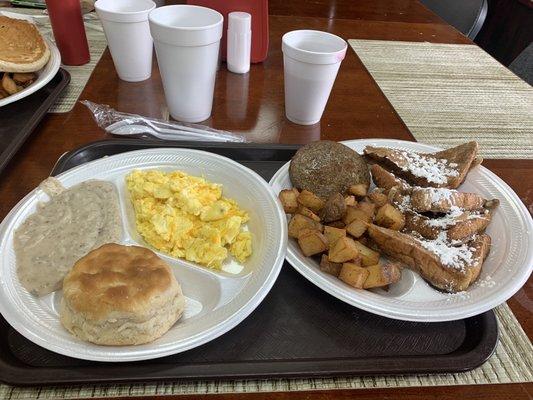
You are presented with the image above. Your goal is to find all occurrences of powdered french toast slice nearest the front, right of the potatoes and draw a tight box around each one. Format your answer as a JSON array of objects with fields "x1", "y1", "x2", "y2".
[{"x1": 368, "y1": 224, "x2": 490, "y2": 293}]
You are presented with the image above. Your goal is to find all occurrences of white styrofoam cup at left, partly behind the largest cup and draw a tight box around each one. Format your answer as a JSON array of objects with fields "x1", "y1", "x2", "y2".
[{"x1": 94, "y1": 0, "x2": 155, "y2": 82}]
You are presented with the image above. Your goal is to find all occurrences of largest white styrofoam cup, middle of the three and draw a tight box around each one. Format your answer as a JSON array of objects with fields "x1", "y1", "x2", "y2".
[{"x1": 149, "y1": 5, "x2": 224, "y2": 122}]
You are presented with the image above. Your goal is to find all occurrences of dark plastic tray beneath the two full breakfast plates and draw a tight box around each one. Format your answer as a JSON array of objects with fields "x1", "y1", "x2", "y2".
[{"x1": 0, "y1": 139, "x2": 498, "y2": 385}]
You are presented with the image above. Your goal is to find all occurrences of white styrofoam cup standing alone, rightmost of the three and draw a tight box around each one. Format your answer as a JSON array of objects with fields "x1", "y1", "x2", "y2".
[{"x1": 281, "y1": 30, "x2": 347, "y2": 125}]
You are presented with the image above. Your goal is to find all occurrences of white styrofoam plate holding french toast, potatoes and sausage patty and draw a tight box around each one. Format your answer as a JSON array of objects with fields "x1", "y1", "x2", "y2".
[{"x1": 270, "y1": 139, "x2": 533, "y2": 322}]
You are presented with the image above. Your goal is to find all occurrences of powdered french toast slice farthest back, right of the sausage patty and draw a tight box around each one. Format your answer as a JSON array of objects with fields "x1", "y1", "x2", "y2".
[{"x1": 364, "y1": 141, "x2": 482, "y2": 189}]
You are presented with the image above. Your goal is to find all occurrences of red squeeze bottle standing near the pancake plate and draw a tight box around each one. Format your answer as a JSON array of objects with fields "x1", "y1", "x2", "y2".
[{"x1": 46, "y1": 0, "x2": 91, "y2": 65}]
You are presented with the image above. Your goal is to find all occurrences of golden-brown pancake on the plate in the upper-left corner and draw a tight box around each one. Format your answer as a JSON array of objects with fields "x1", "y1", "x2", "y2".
[{"x1": 0, "y1": 16, "x2": 50, "y2": 72}]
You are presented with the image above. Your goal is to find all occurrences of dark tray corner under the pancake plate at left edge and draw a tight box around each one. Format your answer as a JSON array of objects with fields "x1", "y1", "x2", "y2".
[{"x1": 0, "y1": 68, "x2": 70, "y2": 172}]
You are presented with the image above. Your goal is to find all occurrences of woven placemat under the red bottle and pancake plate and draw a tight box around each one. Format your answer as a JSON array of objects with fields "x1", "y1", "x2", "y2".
[{"x1": 6, "y1": 8, "x2": 107, "y2": 113}]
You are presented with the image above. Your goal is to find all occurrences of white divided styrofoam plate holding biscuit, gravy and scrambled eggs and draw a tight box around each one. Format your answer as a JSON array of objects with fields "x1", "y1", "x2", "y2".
[{"x1": 0, "y1": 149, "x2": 287, "y2": 361}]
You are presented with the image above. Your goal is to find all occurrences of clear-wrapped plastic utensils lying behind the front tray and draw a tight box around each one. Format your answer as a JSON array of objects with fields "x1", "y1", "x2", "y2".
[{"x1": 81, "y1": 100, "x2": 247, "y2": 142}]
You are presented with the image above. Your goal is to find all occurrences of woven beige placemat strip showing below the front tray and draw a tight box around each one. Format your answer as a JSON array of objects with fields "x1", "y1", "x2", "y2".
[{"x1": 0, "y1": 304, "x2": 533, "y2": 399}]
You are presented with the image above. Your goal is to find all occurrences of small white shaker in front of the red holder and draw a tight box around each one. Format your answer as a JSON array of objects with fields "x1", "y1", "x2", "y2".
[{"x1": 227, "y1": 11, "x2": 252, "y2": 74}]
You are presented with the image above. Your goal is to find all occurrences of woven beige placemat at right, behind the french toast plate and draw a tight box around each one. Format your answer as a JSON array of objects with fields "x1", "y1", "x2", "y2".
[{"x1": 349, "y1": 39, "x2": 533, "y2": 158}]
